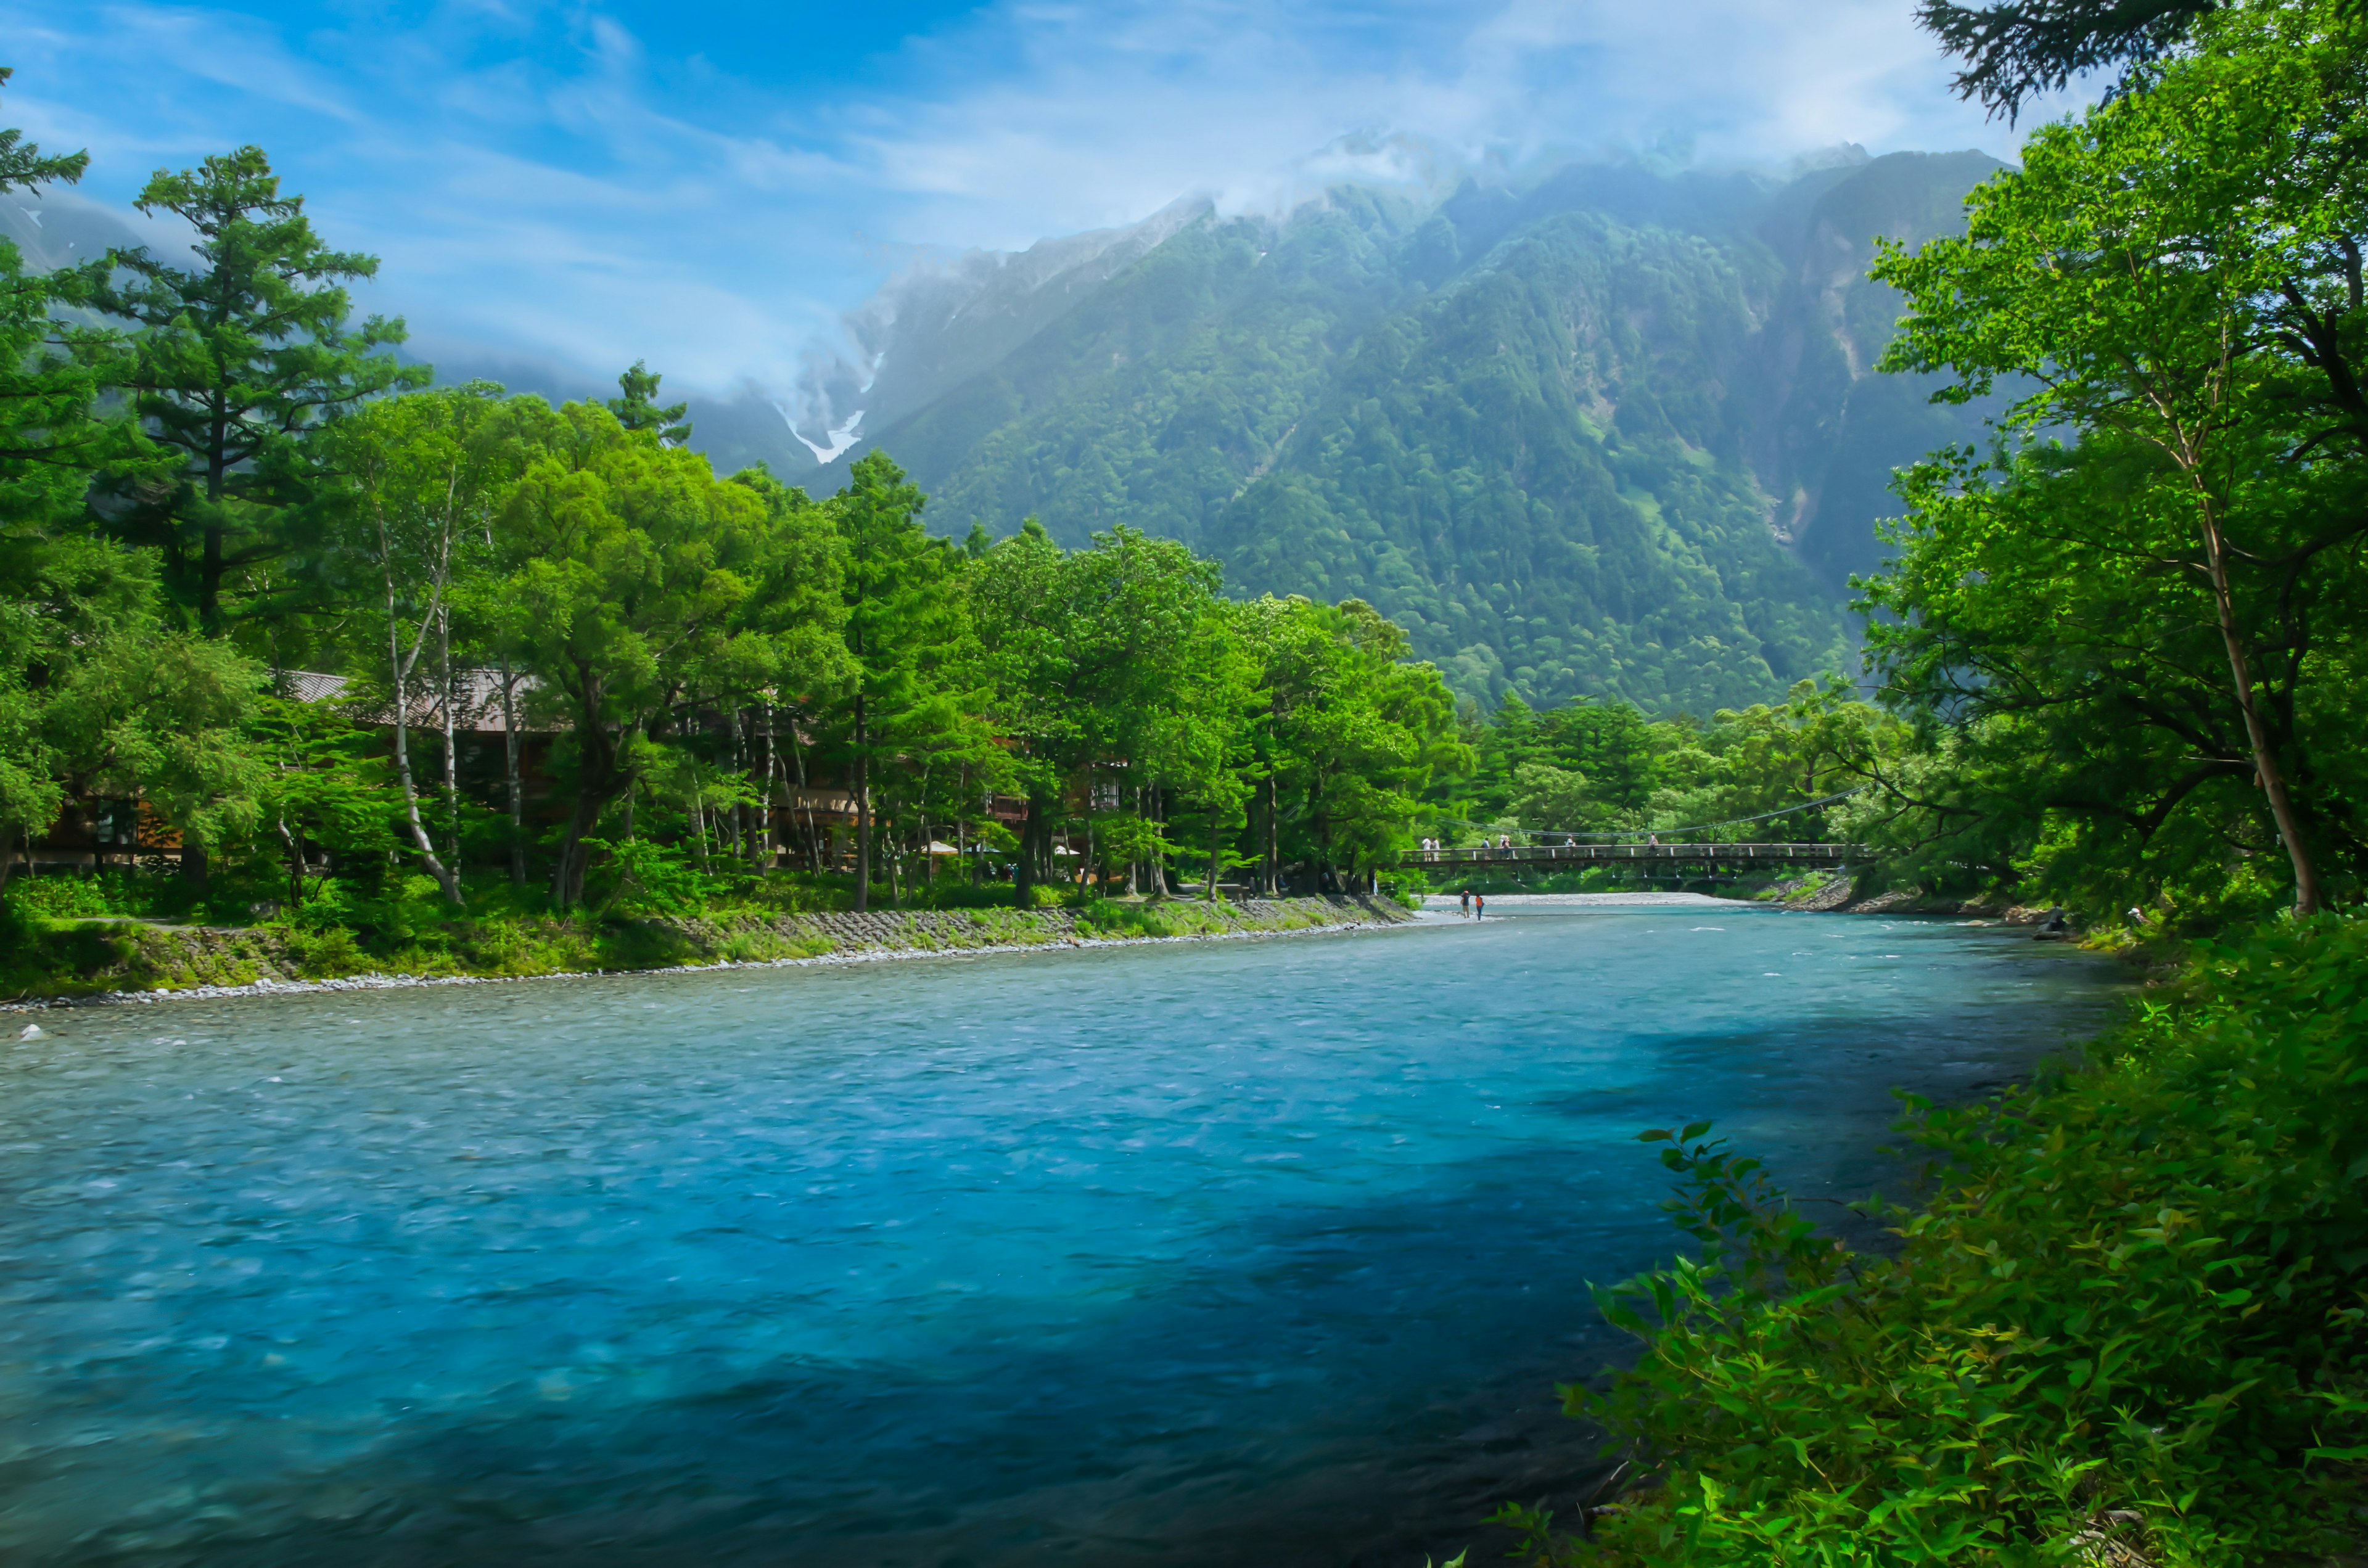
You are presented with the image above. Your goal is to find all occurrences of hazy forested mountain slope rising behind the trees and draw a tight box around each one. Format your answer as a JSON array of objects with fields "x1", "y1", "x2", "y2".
[{"x1": 843, "y1": 154, "x2": 1999, "y2": 708}]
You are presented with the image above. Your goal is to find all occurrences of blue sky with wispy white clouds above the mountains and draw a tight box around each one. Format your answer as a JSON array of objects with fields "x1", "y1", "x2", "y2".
[{"x1": 0, "y1": 0, "x2": 2055, "y2": 404}]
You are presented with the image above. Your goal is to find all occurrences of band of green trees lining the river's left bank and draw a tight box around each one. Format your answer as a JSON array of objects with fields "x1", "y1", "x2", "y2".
[{"x1": 0, "y1": 126, "x2": 1461, "y2": 921}]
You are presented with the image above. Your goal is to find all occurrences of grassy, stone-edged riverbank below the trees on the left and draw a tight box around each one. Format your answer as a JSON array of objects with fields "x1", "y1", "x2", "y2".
[{"x1": 0, "y1": 895, "x2": 1416, "y2": 1011}]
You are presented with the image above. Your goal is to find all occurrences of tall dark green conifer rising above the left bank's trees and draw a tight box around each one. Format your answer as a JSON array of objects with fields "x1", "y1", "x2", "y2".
[{"x1": 97, "y1": 147, "x2": 429, "y2": 634}]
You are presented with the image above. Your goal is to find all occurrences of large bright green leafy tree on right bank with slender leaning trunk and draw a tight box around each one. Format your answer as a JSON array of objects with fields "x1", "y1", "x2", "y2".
[{"x1": 1868, "y1": 7, "x2": 2368, "y2": 912}]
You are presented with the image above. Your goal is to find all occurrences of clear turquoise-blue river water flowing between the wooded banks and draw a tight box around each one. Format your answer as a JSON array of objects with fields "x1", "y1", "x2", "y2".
[{"x1": 0, "y1": 905, "x2": 2112, "y2": 1568}]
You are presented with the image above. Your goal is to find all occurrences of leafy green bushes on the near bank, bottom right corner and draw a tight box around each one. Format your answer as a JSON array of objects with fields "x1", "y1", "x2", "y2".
[{"x1": 1502, "y1": 917, "x2": 2368, "y2": 1568}]
